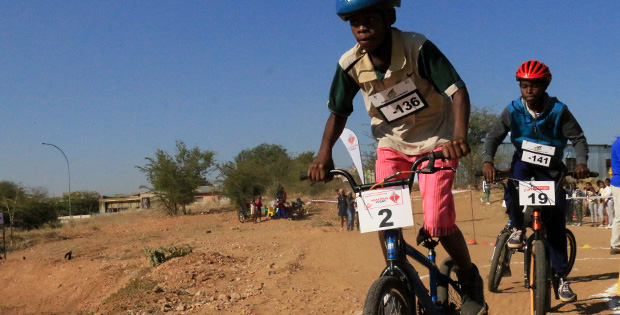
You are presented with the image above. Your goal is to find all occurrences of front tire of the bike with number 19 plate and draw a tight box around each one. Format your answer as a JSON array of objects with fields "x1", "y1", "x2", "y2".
[{"x1": 528, "y1": 240, "x2": 551, "y2": 315}]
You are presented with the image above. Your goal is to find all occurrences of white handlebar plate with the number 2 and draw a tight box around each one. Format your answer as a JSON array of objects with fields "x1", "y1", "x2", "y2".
[{"x1": 357, "y1": 186, "x2": 413, "y2": 233}]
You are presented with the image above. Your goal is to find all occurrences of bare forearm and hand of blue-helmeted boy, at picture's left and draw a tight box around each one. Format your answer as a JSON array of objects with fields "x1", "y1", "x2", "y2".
[{"x1": 308, "y1": 113, "x2": 348, "y2": 182}]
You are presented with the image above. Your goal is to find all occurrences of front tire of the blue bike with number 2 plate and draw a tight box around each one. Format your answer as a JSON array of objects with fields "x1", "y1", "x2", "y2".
[{"x1": 363, "y1": 276, "x2": 416, "y2": 315}]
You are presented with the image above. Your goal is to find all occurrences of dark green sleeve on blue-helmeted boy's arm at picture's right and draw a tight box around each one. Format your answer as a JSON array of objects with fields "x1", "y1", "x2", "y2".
[{"x1": 418, "y1": 40, "x2": 465, "y2": 98}]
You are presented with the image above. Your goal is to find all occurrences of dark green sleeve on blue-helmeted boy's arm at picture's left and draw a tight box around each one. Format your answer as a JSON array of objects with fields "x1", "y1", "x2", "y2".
[{"x1": 327, "y1": 64, "x2": 360, "y2": 117}]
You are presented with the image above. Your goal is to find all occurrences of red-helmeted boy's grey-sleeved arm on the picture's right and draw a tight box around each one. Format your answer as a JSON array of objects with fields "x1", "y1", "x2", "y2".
[{"x1": 560, "y1": 107, "x2": 590, "y2": 179}]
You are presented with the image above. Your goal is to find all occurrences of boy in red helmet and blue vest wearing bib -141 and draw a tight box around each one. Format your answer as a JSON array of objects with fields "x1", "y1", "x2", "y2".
[{"x1": 482, "y1": 60, "x2": 590, "y2": 302}]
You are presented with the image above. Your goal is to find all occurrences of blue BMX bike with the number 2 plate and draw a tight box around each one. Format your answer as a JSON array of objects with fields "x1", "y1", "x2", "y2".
[{"x1": 308, "y1": 152, "x2": 474, "y2": 315}]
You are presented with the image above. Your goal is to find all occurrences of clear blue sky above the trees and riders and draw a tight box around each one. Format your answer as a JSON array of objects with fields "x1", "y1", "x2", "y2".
[{"x1": 0, "y1": 0, "x2": 620, "y2": 195}]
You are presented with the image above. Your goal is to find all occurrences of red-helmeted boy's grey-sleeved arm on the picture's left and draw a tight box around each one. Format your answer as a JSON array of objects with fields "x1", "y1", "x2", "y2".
[{"x1": 482, "y1": 107, "x2": 510, "y2": 183}]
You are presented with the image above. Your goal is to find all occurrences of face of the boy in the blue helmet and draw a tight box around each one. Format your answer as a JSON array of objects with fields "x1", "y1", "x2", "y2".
[{"x1": 349, "y1": 12, "x2": 387, "y2": 52}]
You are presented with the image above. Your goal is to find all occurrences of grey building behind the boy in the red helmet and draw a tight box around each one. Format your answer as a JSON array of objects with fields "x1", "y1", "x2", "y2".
[{"x1": 495, "y1": 142, "x2": 611, "y2": 179}]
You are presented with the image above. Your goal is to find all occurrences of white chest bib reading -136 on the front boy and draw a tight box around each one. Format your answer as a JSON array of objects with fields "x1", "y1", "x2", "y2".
[{"x1": 370, "y1": 79, "x2": 428, "y2": 123}]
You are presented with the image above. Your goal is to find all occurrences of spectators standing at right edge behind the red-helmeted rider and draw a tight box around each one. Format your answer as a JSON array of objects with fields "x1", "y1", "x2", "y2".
[{"x1": 566, "y1": 178, "x2": 615, "y2": 229}]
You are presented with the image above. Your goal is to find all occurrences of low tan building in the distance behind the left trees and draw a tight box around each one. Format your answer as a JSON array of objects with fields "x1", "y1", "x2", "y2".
[{"x1": 99, "y1": 186, "x2": 224, "y2": 213}]
